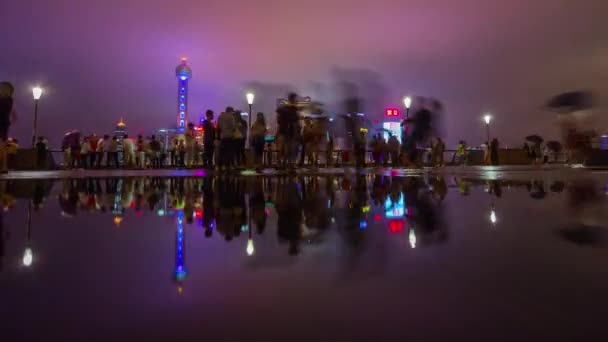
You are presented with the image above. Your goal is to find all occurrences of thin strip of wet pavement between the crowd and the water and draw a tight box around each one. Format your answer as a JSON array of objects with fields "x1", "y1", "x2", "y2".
[{"x1": 0, "y1": 165, "x2": 608, "y2": 179}]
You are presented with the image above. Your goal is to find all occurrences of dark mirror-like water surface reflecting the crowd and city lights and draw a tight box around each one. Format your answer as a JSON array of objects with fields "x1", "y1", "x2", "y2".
[{"x1": 0, "y1": 175, "x2": 608, "y2": 341}]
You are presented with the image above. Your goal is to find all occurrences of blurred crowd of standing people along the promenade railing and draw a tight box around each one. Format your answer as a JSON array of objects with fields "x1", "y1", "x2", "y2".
[{"x1": 57, "y1": 93, "x2": 445, "y2": 170}]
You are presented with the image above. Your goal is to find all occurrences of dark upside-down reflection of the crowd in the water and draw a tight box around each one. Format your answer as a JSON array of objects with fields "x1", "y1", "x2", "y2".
[{"x1": 0, "y1": 174, "x2": 603, "y2": 267}]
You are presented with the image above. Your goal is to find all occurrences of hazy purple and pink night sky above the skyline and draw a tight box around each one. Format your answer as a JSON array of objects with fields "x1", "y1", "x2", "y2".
[{"x1": 0, "y1": 0, "x2": 608, "y2": 145}]
